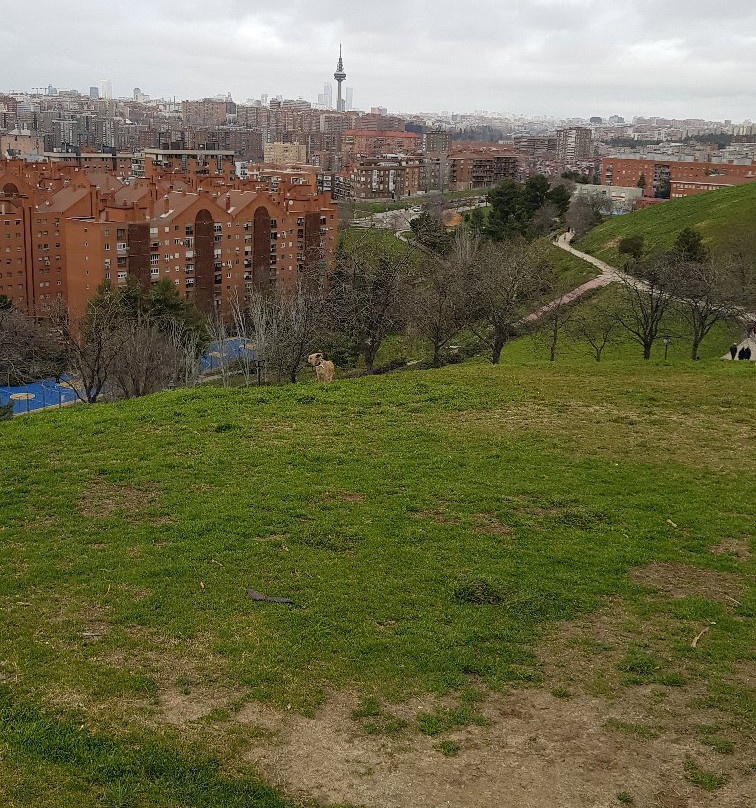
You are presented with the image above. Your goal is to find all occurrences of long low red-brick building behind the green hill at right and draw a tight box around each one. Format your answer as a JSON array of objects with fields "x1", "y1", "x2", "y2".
[{"x1": 601, "y1": 157, "x2": 756, "y2": 199}]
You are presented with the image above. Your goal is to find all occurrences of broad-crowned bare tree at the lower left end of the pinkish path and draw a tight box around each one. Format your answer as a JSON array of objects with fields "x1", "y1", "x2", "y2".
[{"x1": 469, "y1": 239, "x2": 554, "y2": 365}]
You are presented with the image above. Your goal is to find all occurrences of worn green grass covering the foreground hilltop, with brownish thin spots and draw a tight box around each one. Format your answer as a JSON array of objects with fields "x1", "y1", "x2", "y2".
[{"x1": 0, "y1": 357, "x2": 756, "y2": 808}]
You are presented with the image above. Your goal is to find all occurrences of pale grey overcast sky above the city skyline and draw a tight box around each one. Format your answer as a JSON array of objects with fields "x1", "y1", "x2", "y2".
[{"x1": 0, "y1": 0, "x2": 756, "y2": 122}]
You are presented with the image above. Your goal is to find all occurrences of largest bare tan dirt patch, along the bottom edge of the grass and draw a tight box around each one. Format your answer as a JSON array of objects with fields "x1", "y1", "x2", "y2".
[{"x1": 229, "y1": 690, "x2": 750, "y2": 808}]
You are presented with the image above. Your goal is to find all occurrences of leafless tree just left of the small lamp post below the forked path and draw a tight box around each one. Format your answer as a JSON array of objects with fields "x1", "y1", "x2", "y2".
[{"x1": 617, "y1": 256, "x2": 680, "y2": 359}]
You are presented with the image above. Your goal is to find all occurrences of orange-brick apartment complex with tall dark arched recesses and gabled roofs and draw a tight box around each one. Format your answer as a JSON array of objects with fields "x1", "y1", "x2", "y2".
[{"x1": 0, "y1": 158, "x2": 338, "y2": 316}]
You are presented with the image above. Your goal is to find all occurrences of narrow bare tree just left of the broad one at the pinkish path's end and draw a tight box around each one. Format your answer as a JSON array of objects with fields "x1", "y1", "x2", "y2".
[{"x1": 406, "y1": 230, "x2": 478, "y2": 367}]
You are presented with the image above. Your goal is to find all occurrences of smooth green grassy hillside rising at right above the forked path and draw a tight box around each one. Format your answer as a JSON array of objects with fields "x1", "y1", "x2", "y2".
[{"x1": 575, "y1": 183, "x2": 756, "y2": 266}]
